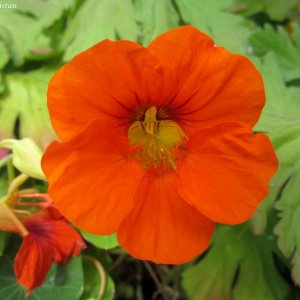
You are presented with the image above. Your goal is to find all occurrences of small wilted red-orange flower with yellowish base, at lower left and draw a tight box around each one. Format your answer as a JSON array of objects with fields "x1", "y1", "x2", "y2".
[{"x1": 0, "y1": 193, "x2": 86, "y2": 296}]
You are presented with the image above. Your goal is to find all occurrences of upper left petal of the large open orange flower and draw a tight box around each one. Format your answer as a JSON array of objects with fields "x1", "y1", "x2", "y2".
[{"x1": 48, "y1": 40, "x2": 177, "y2": 140}]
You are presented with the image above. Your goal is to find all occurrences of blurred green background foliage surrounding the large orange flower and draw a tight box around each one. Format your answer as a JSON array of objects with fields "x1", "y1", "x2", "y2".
[{"x1": 0, "y1": 0, "x2": 300, "y2": 300}]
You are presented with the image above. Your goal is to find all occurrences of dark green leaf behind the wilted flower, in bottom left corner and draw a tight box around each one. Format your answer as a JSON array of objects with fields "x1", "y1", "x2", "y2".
[{"x1": 0, "y1": 251, "x2": 83, "y2": 300}]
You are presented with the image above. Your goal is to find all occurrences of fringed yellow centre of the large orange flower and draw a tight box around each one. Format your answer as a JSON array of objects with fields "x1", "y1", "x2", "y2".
[{"x1": 128, "y1": 106, "x2": 187, "y2": 169}]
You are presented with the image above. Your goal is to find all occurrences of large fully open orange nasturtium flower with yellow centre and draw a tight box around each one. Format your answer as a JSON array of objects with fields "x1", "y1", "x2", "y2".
[{"x1": 42, "y1": 26, "x2": 277, "y2": 264}]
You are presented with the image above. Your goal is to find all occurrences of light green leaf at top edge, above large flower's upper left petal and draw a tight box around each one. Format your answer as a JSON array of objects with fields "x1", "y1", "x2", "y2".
[{"x1": 61, "y1": 0, "x2": 139, "y2": 61}]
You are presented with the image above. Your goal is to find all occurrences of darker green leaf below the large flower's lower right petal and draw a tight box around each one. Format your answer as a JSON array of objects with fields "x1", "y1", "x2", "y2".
[{"x1": 183, "y1": 224, "x2": 288, "y2": 300}]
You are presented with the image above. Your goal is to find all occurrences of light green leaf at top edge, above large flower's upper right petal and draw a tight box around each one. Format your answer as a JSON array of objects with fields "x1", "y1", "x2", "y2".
[{"x1": 175, "y1": 0, "x2": 251, "y2": 54}]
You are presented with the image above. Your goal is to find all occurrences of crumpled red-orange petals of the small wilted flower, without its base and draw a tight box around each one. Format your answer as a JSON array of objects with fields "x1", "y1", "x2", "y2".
[{"x1": 14, "y1": 215, "x2": 86, "y2": 295}]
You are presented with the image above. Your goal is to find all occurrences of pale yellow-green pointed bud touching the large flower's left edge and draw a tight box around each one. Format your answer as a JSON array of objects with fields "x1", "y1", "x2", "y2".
[{"x1": 0, "y1": 138, "x2": 46, "y2": 180}]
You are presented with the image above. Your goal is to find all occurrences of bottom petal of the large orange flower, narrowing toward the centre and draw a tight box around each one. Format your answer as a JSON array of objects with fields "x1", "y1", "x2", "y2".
[{"x1": 118, "y1": 172, "x2": 214, "y2": 264}]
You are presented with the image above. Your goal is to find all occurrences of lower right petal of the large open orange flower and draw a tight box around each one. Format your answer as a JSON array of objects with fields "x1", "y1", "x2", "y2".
[{"x1": 178, "y1": 123, "x2": 278, "y2": 224}]
